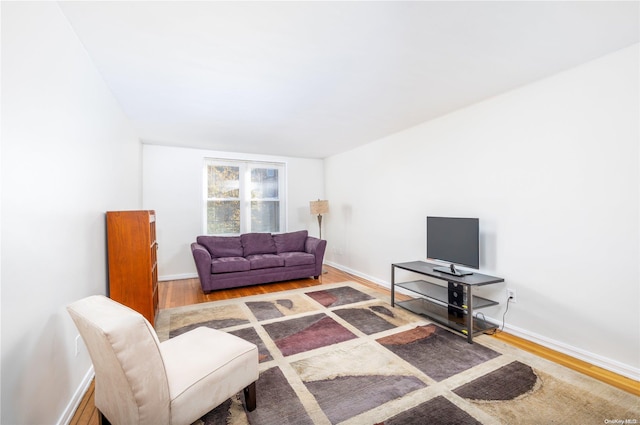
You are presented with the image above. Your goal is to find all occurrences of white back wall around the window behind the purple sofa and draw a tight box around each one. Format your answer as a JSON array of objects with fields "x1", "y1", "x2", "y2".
[{"x1": 143, "y1": 144, "x2": 324, "y2": 280}]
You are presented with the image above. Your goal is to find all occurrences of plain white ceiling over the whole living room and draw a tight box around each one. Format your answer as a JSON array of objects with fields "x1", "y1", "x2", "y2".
[{"x1": 60, "y1": 1, "x2": 640, "y2": 158}]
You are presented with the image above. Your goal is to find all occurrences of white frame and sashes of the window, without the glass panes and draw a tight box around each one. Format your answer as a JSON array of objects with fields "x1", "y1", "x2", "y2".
[{"x1": 202, "y1": 158, "x2": 287, "y2": 236}]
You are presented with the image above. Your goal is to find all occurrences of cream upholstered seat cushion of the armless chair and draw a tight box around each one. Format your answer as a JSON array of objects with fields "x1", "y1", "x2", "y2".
[{"x1": 160, "y1": 327, "x2": 258, "y2": 424}]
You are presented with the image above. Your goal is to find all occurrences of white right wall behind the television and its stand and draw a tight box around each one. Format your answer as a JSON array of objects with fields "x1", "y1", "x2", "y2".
[{"x1": 325, "y1": 45, "x2": 640, "y2": 379}]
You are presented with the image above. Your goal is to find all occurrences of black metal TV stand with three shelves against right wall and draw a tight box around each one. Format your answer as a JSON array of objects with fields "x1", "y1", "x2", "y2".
[{"x1": 391, "y1": 261, "x2": 504, "y2": 344}]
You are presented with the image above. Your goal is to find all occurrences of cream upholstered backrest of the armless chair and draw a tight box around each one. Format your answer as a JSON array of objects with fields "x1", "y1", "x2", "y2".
[{"x1": 67, "y1": 295, "x2": 170, "y2": 425}]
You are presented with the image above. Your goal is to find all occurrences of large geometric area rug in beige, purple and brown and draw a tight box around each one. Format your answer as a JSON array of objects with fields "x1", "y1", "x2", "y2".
[{"x1": 156, "y1": 282, "x2": 640, "y2": 425}]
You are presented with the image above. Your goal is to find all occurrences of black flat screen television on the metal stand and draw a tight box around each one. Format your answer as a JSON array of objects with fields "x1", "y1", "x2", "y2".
[{"x1": 427, "y1": 217, "x2": 480, "y2": 276}]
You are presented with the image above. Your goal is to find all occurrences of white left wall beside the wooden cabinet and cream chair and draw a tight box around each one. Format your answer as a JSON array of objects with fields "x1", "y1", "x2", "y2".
[{"x1": 0, "y1": 2, "x2": 142, "y2": 425}]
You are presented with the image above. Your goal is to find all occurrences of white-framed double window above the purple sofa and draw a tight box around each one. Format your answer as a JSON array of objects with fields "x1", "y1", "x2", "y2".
[{"x1": 204, "y1": 159, "x2": 286, "y2": 235}]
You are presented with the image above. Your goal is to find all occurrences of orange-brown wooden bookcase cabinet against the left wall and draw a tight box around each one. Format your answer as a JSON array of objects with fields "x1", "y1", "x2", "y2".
[{"x1": 107, "y1": 210, "x2": 158, "y2": 325}]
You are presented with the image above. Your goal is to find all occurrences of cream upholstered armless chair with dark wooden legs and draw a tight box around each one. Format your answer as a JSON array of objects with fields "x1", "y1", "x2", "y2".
[{"x1": 67, "y1": 295, "x2": 258, "y2": 425}]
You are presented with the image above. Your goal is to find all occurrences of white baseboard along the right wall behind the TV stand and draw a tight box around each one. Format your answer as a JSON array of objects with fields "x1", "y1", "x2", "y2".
[{"x1": 325, "y1": 261, "x2": 640, "y2": 381}]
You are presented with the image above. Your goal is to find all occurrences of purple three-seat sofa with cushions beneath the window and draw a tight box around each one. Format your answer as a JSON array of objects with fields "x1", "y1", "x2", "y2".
[{"x1": 191, "y1": 230, "x2": 327, "y2": 292}]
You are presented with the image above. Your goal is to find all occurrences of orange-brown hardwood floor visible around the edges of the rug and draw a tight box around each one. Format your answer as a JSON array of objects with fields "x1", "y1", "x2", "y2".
[{"x1": 70, "y1": 265, "x2": 640, "y2": 425}]
